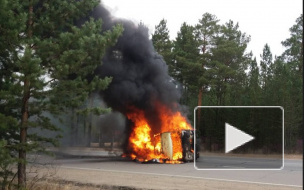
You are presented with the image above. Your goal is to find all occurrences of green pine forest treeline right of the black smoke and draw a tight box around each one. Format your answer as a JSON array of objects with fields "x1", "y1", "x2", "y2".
[{"x1": 152, "y1": 13, "x2": 303, "y2": 152}]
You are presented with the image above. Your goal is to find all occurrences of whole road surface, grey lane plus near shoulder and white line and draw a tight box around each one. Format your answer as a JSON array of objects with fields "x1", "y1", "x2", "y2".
[{"x1": 31, "y1": 154, "x2": 303, "y2": 189}]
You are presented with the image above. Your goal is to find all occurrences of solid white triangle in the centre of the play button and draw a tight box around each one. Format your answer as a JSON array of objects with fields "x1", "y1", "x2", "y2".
[{"x1": 225, "y1": 123, "x2": 254, "y2": 153}]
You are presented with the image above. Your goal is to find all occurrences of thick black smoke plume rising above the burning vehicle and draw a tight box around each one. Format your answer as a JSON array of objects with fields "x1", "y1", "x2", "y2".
[{"x1": 91, "y1": 5, "x2": 181, "y2": 147}]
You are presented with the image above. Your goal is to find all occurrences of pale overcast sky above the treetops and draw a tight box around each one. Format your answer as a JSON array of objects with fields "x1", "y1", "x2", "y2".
[{"x1": 101, "y1": 0, "x2": 303, "y2": 61}]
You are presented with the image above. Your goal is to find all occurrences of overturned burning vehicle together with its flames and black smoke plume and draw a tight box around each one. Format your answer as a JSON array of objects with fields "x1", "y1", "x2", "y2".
[{"x1": 88, "y1": 5, "x2": 198, "y2": 163}]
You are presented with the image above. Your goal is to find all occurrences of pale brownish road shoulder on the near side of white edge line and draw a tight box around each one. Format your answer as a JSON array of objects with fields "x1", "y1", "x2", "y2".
[{"x1": 28, "y1": 167, "x2": 302, "y2": 190}]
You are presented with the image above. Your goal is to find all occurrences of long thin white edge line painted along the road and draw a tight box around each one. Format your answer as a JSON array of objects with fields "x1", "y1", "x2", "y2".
[{"x1": 60, "y1": 166, "x2": 303, "y2": 188}]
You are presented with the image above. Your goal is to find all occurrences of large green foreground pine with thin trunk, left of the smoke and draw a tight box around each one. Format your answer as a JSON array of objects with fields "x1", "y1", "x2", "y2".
[{"x1": 0, "y1": 0, "x2": 122, "y2": 188}]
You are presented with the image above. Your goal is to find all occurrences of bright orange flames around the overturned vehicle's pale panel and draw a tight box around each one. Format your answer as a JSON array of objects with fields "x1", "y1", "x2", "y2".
[{"x1": 127, "y1": 103, "x2": 192, "y2": 163}]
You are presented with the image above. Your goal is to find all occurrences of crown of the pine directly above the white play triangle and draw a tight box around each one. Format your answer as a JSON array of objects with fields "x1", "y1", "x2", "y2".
[{"x1": 208, "y1": 20, "x2": 251, "y2": 105}]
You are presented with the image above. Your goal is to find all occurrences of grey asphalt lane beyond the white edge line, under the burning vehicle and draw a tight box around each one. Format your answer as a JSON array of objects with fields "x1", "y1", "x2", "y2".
[{"x1": 47, "y1": 157, "x2": 303, "y2": 187}]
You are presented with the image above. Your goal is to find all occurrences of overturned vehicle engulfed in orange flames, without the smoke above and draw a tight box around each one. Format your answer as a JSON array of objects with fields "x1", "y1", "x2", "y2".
[{"x1": 126, "y1": 104, "x2": 199, "y2": 163}]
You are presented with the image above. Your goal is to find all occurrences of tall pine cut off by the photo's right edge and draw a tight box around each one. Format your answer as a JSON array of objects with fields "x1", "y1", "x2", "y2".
[{"x1": 276, "y1": 14, "x2": 303, "y2": 151}]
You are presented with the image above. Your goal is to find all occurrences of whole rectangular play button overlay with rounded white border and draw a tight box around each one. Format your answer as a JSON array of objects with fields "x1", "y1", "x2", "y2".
[{"x1": 193, "y1": 106, "x2": 284, "y2": 170}]
